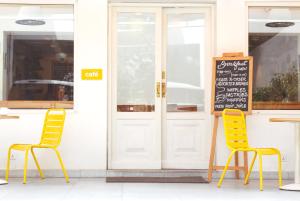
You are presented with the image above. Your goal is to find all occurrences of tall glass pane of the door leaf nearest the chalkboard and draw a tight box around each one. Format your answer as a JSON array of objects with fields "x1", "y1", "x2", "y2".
[{"x1": 167, "y1": 14, "x2": 205, "y2": 112}]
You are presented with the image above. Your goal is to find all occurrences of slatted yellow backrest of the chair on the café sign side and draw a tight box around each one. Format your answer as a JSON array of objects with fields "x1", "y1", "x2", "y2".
[{"x1": 40, "y1": 109, "x2": 66, "y2": 147}]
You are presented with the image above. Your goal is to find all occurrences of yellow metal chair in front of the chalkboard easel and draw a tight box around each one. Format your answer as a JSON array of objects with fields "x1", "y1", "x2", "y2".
[{"x1": 218, "y1": 109, "x2": 282, "y2": 190}]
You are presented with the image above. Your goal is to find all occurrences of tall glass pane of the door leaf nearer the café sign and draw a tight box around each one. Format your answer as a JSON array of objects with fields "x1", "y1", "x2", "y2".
[{"x1": 117, "y1": 13, "x2": 155, "y2": 112}]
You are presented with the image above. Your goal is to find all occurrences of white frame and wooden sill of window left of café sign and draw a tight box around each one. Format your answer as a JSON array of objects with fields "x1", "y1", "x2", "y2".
[{"x1": 0, "y1": 0, "x2": 78, "y2": 109}]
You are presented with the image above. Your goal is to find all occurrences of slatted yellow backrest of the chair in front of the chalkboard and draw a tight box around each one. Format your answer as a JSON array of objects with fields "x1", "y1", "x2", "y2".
[{"x1": 222, "y1": 109, "x2": 249, "y2": 149}]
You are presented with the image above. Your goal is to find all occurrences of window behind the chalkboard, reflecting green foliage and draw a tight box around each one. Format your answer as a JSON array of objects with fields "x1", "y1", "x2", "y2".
[{"x1": 248, "y1": 7, "x2": 300, "y2": 110}]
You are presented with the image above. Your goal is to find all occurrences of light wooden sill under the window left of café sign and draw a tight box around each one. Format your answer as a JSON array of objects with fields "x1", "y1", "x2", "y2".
[{"x1": 0, "y1": 101, "x2": 74, "y2": 109}]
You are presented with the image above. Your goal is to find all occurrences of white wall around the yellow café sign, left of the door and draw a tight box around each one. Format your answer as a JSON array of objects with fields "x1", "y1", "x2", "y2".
[{"x1": 0, "y1": 0, "x2": 107, "y2": 170}]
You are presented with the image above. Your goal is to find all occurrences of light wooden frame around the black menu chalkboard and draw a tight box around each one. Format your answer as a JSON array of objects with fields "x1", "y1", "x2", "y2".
[{"x1": 211, "y1": 53, "x2": 253, "y2": 116}]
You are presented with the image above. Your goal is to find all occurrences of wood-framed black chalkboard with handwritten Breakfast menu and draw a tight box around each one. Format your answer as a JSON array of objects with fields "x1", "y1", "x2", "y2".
[{"x1": 211, "y1": 53, "x2": 253, "y2": 114}]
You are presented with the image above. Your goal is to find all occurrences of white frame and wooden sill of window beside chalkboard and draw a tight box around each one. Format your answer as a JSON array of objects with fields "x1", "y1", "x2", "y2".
[{"x1": 244, "y1": 0, "x2": 300, "y2": 111}]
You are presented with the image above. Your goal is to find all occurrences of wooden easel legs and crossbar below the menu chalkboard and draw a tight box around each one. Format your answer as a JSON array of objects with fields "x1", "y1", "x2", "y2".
[{"x1": 207, "y1": 115, "x2": 248, "y2": 182}]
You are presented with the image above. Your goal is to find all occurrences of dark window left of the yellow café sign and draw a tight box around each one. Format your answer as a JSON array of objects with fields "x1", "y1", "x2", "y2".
[{"x1": 0, "y1": 4, "x2": 74, "y2": 108}]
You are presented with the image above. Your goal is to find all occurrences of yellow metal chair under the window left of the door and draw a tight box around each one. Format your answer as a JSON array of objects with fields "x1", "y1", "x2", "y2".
[{"x1": 5, "y1": 109, "x2": 69, "y2": 184}]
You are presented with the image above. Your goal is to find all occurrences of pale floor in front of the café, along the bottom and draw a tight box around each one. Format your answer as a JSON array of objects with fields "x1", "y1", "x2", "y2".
[{"x1": 0, "y1": 178, "x2": 300, "y2": 201}]
